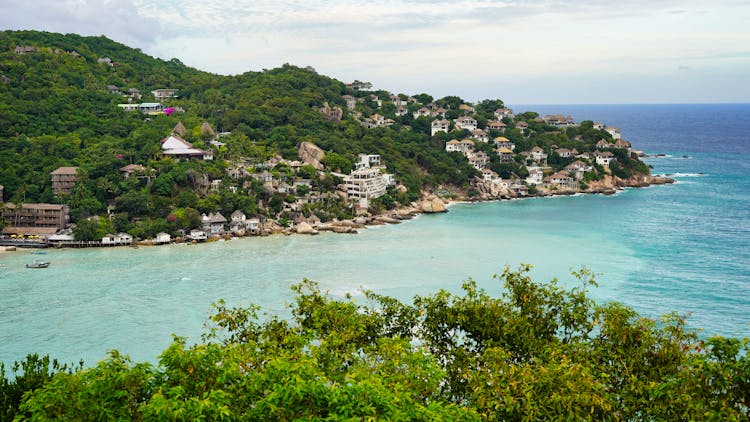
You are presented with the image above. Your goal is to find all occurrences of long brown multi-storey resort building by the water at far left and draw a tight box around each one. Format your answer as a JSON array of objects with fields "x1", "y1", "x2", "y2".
[{"x1": 0, "y1": 202, "x2": 70, "y2": 235}]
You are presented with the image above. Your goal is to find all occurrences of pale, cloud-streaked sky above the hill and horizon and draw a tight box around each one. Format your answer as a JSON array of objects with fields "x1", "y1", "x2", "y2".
[{"x1": 0, "y1": 0, "x2": 750, "y2": 104}]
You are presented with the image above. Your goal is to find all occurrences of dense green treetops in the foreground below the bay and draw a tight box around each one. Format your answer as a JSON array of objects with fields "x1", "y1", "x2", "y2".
[{"x1": 0, "y1": 266, "x2": 750, "y2": 421}]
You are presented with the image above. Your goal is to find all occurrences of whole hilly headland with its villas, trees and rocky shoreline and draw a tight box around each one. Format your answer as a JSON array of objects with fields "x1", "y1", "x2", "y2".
[{"x1": 0, "y1": 31, "x2": 671, "y2": 246}]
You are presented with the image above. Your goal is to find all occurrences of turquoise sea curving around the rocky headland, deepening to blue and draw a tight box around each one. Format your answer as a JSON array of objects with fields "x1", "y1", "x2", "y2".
[{"x1": 0, "y1": 104, "x2": 750, "y2": 365}]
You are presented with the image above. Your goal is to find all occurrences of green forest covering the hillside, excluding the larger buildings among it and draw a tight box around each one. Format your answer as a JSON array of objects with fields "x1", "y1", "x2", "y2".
[{"x1": 0, "y1": 31, "x2": 648, "y2": 239}]
